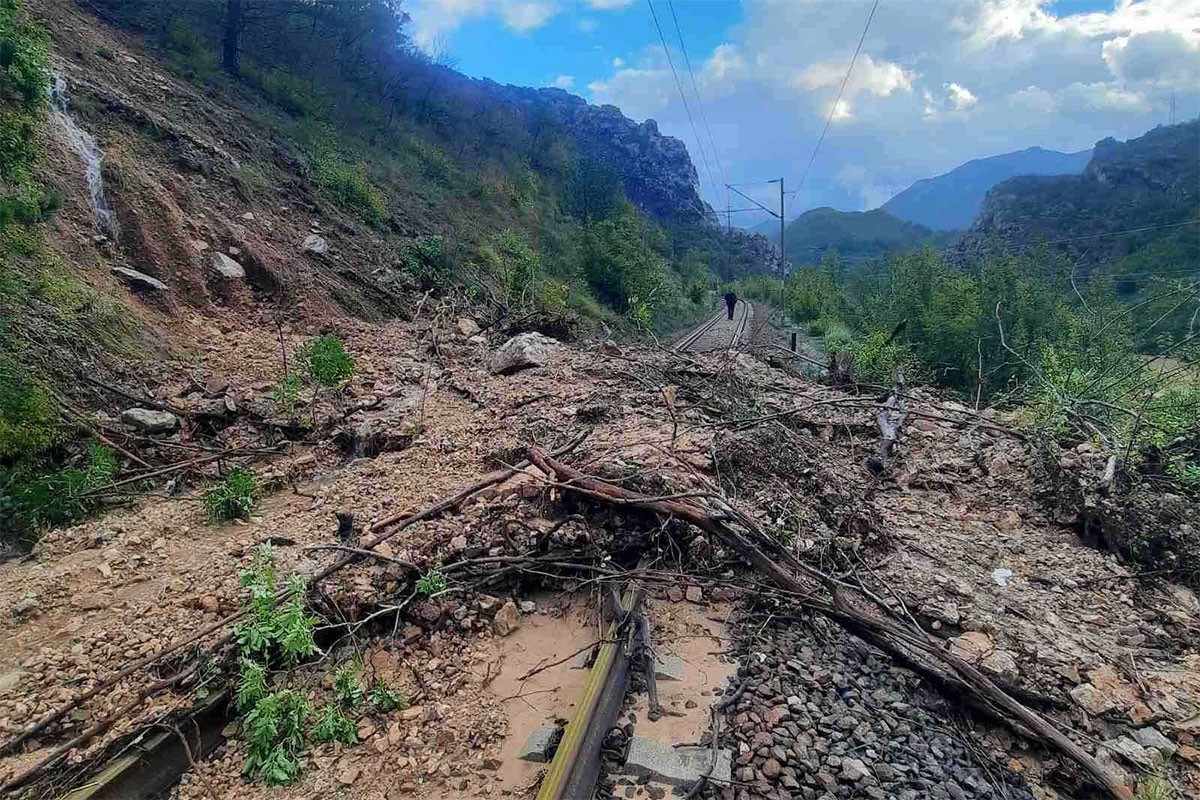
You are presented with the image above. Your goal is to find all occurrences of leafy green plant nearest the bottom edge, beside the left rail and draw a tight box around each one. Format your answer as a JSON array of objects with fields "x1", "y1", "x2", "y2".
[{"x1": 242, "y1": 690, "x2": 308, "y2": 786}]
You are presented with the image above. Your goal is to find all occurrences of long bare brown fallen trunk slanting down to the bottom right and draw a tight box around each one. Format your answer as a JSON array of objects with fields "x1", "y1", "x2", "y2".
[{"x1": 529, "y1": 447, "x2": 1134, "y2": 800}]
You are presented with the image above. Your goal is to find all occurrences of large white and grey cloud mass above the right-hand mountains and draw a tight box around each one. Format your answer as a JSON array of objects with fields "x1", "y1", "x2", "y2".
[{"x1": 583, "y1": 0, "x2": 1200, "y2": 215}]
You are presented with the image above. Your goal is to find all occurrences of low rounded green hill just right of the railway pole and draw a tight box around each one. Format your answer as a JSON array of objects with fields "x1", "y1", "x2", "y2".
[{"x1": 773, "y1": 207, "x2": 955, "y2": 264}]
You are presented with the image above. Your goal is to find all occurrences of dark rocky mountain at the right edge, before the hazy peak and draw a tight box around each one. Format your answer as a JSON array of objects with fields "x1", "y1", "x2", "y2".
[{"x1": 964, "y1": 120, "x2": 1200, "y2": 271}]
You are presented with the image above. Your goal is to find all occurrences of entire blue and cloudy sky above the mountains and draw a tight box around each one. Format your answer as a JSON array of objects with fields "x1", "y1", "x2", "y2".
[{"x1": 404, "y1": 0, "x2": 1200, "y2": 227}]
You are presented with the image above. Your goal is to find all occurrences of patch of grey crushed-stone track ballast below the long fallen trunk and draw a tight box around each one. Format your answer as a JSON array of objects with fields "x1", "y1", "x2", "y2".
[{"x1": 727, "y1": 619, "x2": 1032, "y2": 800}]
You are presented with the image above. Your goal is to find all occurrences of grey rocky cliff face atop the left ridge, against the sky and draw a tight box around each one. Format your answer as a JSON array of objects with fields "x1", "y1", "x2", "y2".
[{"x1": 472, "y1": 80, "x2": 716, "y2": 224}]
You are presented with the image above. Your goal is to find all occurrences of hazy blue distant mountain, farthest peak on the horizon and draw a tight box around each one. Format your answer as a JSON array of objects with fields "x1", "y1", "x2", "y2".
[{"x1": 880, "y1": 148, "x2": 1092, "y2": 230}]
